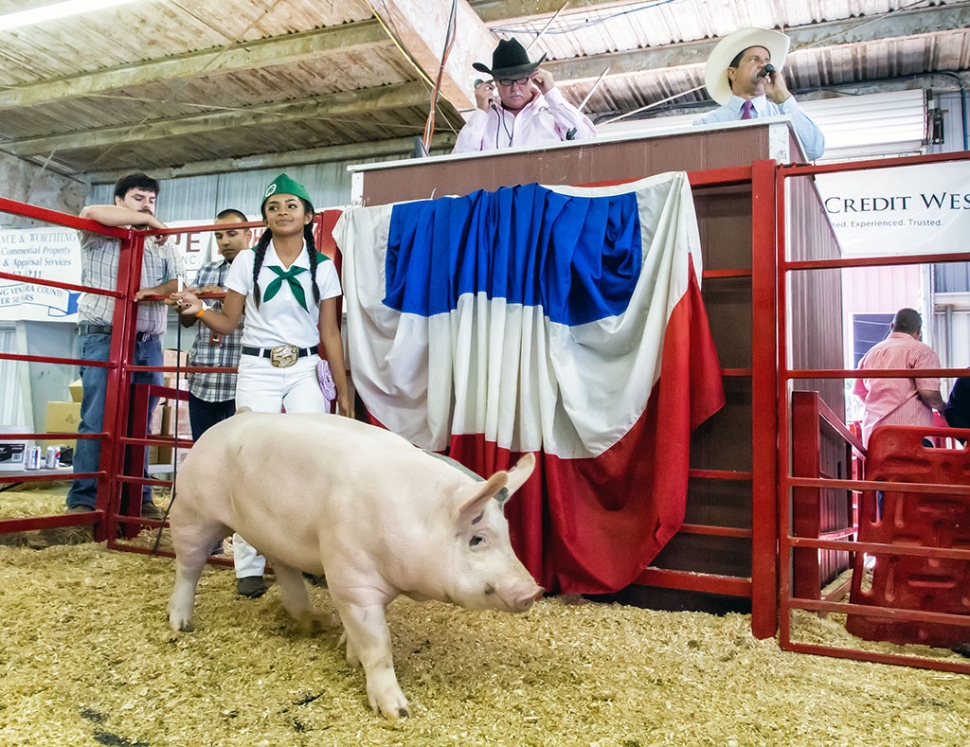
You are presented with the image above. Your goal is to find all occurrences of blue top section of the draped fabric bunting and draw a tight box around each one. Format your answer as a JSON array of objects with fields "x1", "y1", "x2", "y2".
[{"x1": 384, "y1": 184, "x2": 643, "y2": 325}]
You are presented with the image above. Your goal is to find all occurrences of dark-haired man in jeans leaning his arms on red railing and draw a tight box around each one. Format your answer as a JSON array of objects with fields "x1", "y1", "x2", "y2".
[{"x1": 66, "y1": 174, "x2": 182, "y2": 520}]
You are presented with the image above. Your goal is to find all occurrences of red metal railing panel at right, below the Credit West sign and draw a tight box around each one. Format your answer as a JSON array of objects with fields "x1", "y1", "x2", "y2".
[{"x1": 775, "y1": 153, "x2": 970, "y2": 673}]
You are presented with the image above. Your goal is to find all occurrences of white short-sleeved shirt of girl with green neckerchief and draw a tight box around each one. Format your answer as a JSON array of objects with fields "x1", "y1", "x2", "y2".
[{"x1": 226, "y1": 241, "x2": 341, "y2": 348}]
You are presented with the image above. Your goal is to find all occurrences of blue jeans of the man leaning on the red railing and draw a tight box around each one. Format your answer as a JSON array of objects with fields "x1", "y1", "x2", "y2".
[{"x1": 67, "y1": 335, "x2": 163, "y2": 509}]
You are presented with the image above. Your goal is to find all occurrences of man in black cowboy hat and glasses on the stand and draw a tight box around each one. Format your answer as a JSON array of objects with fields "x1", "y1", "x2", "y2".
[{"x1": 452, "y1": 39, "x2": 596, "y2": 153}]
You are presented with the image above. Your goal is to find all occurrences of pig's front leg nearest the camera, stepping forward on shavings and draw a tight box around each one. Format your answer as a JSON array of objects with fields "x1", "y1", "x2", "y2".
[{"x1": 331, "y1": 589, "x2": 411, "y2": 721}]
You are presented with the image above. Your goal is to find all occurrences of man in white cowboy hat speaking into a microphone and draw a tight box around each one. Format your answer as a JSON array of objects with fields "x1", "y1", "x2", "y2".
[{"x1": 694, "y1": 28, "x2": 825, "y2": 161}]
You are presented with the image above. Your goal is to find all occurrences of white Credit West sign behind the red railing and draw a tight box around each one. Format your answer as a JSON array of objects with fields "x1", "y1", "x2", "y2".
[{"x1": 816, "y1": 161, "x2": 970, "y2": 255}]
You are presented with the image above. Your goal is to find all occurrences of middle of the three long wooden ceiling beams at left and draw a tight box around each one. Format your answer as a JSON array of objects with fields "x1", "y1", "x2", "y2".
[{"x1": 3, "y1": 81, "x2": 428, "y2": 158}]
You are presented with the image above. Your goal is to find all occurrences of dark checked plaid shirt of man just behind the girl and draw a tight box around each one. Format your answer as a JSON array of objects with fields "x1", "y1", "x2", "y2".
[{"x1": 186, "y1": 257, "x2": 243, "y2": 402}]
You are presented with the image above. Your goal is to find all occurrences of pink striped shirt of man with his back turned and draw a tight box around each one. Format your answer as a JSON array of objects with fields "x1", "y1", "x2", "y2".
[{"x1": 852, "y1": 332, "x2": 941, "y2": 446}]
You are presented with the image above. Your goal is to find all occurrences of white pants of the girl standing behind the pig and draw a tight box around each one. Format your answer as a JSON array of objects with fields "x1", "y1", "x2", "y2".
[{"x1": 232, "y1": 355, "x2": 330, "y2": 578}]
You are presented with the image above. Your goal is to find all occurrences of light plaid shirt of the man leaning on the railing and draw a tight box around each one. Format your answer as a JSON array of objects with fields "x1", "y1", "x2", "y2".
[{"x1": 77, "y1": 231, "x2": 182, "y2": 335}]
